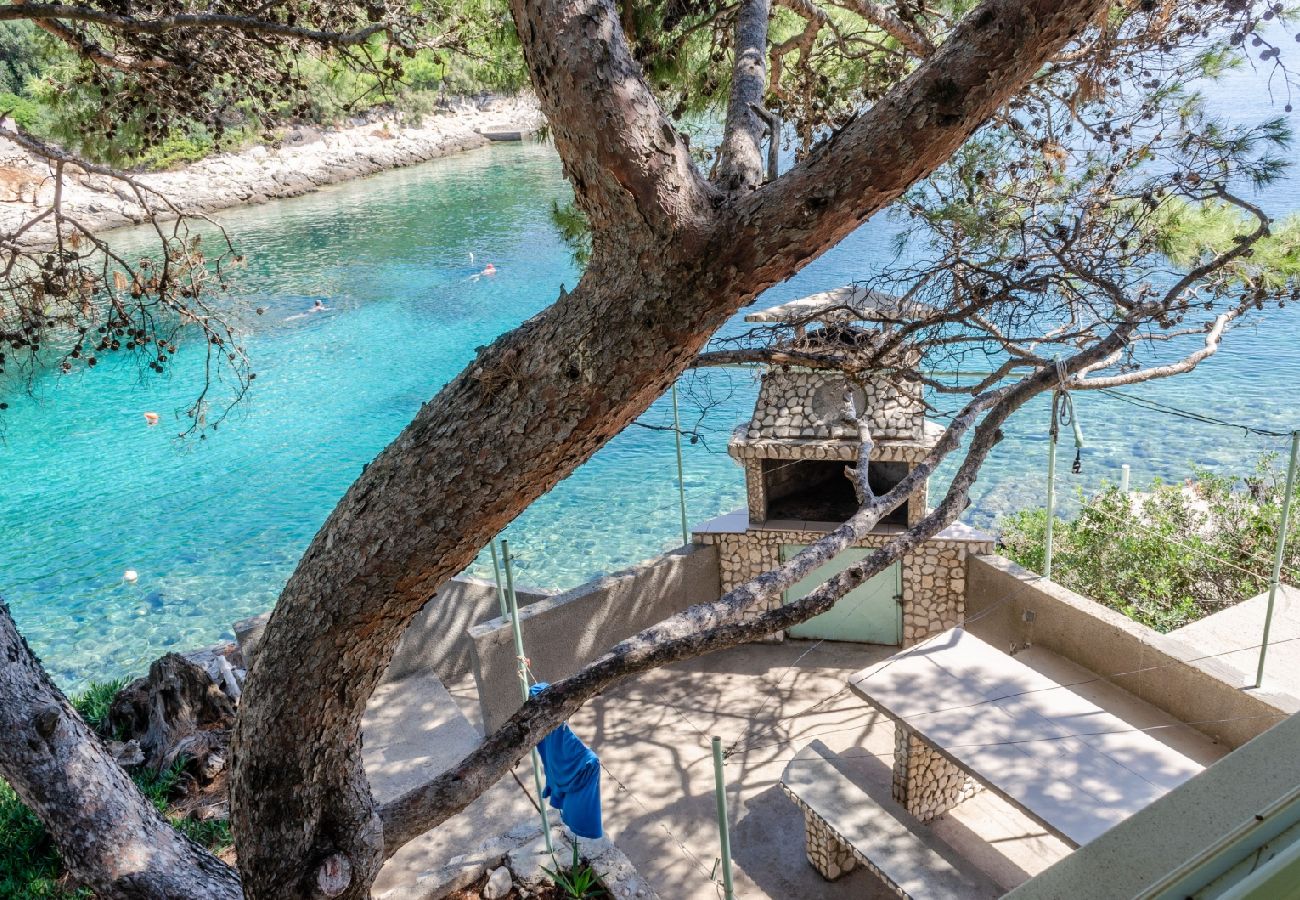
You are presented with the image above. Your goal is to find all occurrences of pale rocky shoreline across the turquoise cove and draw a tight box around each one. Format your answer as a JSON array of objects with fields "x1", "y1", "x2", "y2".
[{"x1": 0, "y1": 95, "x2": 545, "y2": 246}]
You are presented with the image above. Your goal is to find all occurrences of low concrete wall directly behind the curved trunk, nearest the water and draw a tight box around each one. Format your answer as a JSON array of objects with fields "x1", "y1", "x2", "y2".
[{"x1": 234, "y1": 577, "x2": 554, "y2": 683}]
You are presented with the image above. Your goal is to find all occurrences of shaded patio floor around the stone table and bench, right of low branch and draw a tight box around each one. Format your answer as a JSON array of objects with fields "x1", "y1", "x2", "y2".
[{"x1": 571, "y1": 641, "x2": 1222, "y2": 900}]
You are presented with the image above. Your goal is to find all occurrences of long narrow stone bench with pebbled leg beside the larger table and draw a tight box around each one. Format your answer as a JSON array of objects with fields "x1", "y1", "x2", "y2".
[{"x1": 780, "y1": 741, "x2": 1002, "y2": 900}]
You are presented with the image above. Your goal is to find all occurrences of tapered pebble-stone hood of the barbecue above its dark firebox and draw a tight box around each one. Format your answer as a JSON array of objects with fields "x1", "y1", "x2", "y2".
[{"x1": 748, "y1": 371, "x2": 924, "y2": 441}]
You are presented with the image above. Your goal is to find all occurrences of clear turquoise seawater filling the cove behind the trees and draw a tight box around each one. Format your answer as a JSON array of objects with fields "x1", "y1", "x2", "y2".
[{"x1": 0, "y1": 70, "x2": 1300, "y2": 685}]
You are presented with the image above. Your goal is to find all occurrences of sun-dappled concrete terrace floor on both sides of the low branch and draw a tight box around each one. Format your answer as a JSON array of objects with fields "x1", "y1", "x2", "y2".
[{"x1": 367, "y1": 632, "x2": 1227, "y2": 900}]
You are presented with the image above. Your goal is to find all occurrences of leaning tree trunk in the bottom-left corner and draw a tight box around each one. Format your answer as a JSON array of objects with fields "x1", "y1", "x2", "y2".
[{"x1": 0, "y1": 602, "x2": 242, "y2": 900}]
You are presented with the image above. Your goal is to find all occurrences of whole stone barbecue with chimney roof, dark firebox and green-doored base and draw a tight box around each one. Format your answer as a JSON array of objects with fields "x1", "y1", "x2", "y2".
[{"x1": 694, "y1": 286, "x2": 993, "y2": 646}]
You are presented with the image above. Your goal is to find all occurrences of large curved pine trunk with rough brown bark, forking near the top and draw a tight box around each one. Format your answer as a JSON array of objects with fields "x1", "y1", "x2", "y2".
[{"x1": 231, "y1": 0, "x2": 1105, "y2": 897}]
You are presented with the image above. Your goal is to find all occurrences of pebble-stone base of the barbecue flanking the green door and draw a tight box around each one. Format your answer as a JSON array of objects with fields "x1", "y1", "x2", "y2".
[{"x1": 696, "y1": 528, "x2": 993, "y2": 646}]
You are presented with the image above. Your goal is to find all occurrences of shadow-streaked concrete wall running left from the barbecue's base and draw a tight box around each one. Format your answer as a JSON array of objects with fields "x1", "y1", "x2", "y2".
[{"x1": 469, "y1": 544, "x2": 720, "y2": 734}]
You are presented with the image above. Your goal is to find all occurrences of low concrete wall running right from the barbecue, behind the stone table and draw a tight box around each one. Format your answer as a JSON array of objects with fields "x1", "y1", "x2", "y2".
[{"x1": 966, "y1": 555, "x2": 1300, "y2": 748}]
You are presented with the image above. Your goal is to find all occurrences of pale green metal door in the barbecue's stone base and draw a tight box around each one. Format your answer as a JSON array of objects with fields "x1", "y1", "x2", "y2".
[{"x1": 781, "y1": 544, "x2": 902, "y2": 645}]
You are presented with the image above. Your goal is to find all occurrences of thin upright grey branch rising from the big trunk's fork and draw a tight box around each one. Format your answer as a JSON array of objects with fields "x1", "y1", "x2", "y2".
[{"x1": 718, "y1": 0, "x2": 777, "y2": 191}]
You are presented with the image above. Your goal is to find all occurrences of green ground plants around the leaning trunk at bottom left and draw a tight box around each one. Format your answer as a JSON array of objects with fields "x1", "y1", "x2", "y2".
[{"x1": 0, "y1": 680, "x2": 234, "y2": 900}]
